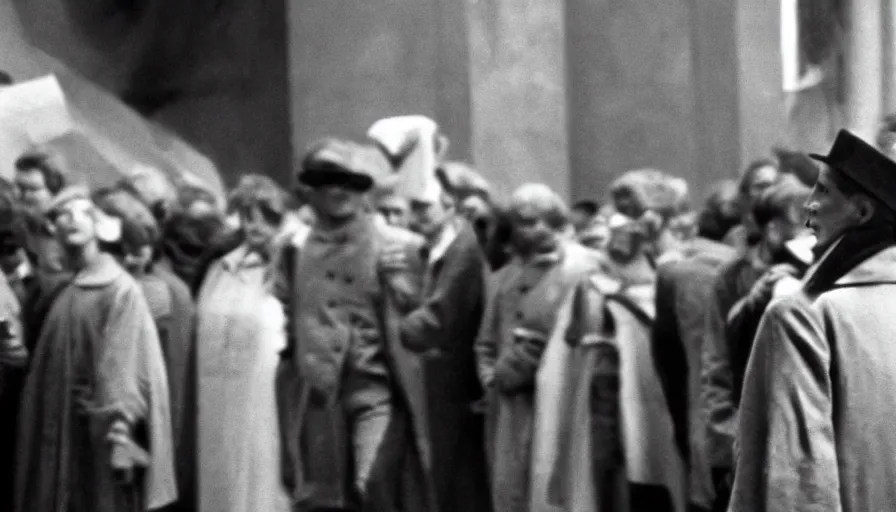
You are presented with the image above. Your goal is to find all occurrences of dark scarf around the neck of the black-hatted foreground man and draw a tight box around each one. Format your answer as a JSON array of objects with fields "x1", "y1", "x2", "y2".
[{"x1": 803, "y1": 225, "x2": 896, "y2": 296}]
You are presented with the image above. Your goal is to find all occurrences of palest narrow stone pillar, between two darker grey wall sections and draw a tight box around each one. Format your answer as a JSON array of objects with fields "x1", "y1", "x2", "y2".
[{"x1": 466, "y1": 0, "x2": 570, "y2": 200}]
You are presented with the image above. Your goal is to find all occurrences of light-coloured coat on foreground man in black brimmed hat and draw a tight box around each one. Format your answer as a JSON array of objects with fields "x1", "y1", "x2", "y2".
[{"x1": 729, "y1": 247, "x2": 896, "y2": 512}]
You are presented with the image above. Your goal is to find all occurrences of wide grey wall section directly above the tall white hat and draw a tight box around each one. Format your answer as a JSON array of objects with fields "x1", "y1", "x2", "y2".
[{"x1": 288, "y1": 0, "x2": 470, "y2": 171}]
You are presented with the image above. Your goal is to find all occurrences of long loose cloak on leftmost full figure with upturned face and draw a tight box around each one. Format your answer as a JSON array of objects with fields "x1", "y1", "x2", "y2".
[{"x1": 16, "y1": 254, "x2": 177, "y2": 512}]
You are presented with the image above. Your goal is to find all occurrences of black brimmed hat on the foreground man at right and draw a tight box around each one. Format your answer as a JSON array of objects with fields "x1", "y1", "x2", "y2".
[{"x1": 809, "y1": 130, "x2": 896, "y2": 211}]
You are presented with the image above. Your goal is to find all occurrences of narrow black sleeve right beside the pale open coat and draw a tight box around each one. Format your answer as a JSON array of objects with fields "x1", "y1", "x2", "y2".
[{"x1": 651, "y1": 264, "x2": 690, "y2": 460}]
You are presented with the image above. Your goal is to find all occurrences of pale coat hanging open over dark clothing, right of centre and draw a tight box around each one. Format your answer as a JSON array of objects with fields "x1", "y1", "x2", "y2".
[{"x1": 552, "y1": 268, "x2": 686, "y2": 512}]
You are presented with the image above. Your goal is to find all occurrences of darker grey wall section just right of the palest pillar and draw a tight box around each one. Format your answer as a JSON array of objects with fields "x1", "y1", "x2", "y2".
[{"x1": 566, "y1": 0, "x2": 700, "y2": 204}]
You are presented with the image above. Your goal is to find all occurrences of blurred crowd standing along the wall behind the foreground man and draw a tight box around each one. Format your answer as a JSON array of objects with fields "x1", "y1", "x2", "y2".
[{"x1": 0, "y1": 105, "x2": 896, "y2": 512}]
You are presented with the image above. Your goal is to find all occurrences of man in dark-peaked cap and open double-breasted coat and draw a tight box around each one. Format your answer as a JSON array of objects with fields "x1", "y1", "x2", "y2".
[{"x1": 275, "y1": 139, "x2": 435, "y2": 512}]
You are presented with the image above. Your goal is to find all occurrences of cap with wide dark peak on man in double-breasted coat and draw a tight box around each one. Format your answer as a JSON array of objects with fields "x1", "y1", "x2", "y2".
[{"x1": 298, "y1": 139, "x2": 374, "y2": 192}]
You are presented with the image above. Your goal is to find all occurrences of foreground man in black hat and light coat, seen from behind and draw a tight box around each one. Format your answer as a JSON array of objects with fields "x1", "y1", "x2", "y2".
[{"x1": 729, "y1": 130, "x2": 896, "y2": 512}]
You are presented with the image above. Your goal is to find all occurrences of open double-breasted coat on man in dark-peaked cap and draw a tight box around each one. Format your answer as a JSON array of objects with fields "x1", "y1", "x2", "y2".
[{"x1": 274, "y1": 218, "x2": 436, "y2": 511}]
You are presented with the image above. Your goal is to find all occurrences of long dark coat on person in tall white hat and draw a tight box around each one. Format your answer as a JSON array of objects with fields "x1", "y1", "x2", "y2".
[{"x1": 401, "y1": 219, "x2": 491, "y2": 512}]
